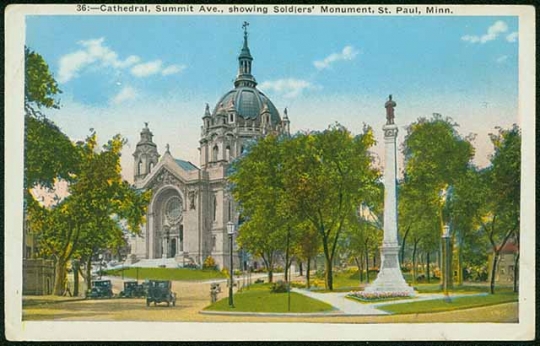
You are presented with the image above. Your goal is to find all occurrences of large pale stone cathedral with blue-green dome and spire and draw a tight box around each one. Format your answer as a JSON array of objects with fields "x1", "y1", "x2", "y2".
[{"x1": 129, "y1": 23, "x2": 290, "y2": 268}]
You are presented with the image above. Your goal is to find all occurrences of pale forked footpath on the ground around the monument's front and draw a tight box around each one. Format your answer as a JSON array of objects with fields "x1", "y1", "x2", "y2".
[{"x1": 292, "y1": 288, "x2": 487, "y2": 315}]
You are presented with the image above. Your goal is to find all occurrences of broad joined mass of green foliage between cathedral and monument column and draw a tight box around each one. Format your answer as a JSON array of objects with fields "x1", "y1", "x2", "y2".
[{"x1": 229, "y1": 125, "x2": 380, "y2": 288}]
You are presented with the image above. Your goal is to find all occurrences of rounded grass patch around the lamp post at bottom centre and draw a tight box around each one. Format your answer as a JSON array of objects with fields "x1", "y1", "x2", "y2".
[{"x1": 204, "y1": 284, "x2": 333, "y2": 313}]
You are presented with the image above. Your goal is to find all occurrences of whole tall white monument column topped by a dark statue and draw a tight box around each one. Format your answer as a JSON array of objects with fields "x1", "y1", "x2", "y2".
[{"x1": 365, "y1": 95, "x2": 414, "y2": 295}]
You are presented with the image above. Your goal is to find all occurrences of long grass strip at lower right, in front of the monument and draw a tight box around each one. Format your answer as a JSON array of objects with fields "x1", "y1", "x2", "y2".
[{"x1": 380, "y1": 292, "x2": 518, "y2": 314}]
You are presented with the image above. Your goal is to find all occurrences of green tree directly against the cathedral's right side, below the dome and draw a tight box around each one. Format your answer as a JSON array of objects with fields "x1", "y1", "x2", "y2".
[{"x1": 229, "y1": 134, "x2": 295, "y2": 282}]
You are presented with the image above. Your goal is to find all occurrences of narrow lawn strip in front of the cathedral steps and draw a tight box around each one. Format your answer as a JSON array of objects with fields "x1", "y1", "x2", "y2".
[{"x1": 105, "y1": 268, "x2": 226, "y2": 281}]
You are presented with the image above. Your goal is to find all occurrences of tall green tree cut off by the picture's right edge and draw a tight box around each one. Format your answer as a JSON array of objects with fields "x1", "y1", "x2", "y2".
[{"x1": 479, "y1": 124, "x2": 521, "y2": 294}]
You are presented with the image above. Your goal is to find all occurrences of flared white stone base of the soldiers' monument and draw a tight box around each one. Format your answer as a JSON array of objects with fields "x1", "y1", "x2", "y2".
[{"x1": 364, "y1": 244, "x2": 415, "y2": 296}]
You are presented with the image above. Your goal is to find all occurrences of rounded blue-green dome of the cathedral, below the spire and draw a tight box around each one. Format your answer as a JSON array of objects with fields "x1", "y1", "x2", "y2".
[{"x1": 213, "y1": 86, "x2": 281, "y2": 125}]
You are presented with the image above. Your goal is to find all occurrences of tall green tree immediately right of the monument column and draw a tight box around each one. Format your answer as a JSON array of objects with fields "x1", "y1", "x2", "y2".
[{"x1": 399, "y1": 114, "x2": 474, "y2": 286}]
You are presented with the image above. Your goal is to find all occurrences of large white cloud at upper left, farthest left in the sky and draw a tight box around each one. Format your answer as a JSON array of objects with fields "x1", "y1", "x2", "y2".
[{"x1": 58, "y1": 37, "x2": 140, "y2": 83}]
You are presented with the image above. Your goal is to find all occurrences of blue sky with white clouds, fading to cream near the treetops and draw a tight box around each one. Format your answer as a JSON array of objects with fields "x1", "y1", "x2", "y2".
[{"x1": 26, "y1": 15, "x2": 520, "y2": 181}]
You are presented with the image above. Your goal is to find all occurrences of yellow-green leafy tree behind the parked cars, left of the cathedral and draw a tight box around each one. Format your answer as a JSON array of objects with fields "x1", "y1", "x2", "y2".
[{"x1": 28, "y1": 133, "x2": 150, "y2": 295}]
